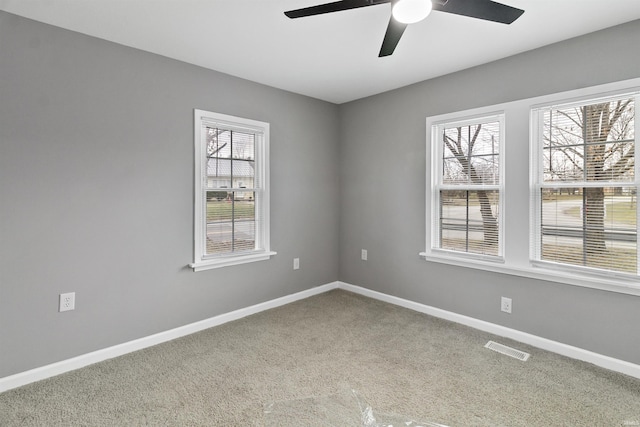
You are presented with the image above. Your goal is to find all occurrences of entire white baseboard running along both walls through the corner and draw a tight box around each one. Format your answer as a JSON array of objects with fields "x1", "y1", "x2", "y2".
[{"x1": 0, "y1": 282, "x2": 640, "y2": 393}]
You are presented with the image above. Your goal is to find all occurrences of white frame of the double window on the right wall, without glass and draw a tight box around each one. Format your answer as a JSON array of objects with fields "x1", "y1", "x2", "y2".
[{"x1": 419, "y1": 78, "x2": 640, "y2": 296}]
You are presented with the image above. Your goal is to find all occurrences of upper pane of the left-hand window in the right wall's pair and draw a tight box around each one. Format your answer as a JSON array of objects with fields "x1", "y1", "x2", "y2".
[{"x1": 442, "y1": 121, "x2": 500, "y2": 185}]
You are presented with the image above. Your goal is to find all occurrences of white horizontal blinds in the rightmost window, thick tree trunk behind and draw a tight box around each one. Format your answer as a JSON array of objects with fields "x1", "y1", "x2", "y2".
[{"x1": 536, "y1": 95, "x2": 638, "y2": 274}]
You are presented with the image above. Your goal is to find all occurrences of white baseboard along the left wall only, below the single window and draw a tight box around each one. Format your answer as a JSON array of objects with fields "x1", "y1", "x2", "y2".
[{"x1": 0, "y1": 282, "x2": 338, "y2": 393}]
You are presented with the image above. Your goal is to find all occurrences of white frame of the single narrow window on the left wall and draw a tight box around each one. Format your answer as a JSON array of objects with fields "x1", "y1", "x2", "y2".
[{"x1": 189, "y1": 109, "x2": 276, "y2": 271}]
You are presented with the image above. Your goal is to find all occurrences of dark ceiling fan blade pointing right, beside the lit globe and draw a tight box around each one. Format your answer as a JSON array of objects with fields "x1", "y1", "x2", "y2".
[{"x1": 433, "y1": 0, "x2": 524, "y2": 24}]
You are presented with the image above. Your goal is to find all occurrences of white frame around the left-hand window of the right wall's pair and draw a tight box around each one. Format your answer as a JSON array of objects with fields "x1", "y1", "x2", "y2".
[{"x1": 427, "y1": 111, "x2": 505, "y2": 263}]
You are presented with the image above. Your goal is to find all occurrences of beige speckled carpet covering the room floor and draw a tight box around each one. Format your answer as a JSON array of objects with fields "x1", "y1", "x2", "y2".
[{"x1": 0, "y1": 290, "x2": 640, "y2": 427}]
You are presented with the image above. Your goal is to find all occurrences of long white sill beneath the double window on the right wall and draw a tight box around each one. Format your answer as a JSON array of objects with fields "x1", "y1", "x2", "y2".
[{"x1": 419, "y1": 252, "x2": 640, "y2": 296}]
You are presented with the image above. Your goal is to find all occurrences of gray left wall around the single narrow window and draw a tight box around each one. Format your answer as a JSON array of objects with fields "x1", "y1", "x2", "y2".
[{"x1": 0, "y1": 12, "x2": 339, "y2": 377}]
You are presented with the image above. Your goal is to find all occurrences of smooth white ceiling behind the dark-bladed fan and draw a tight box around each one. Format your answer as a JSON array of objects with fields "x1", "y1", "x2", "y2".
[{"x1": 0, "y1": 0, "x2": 640, "y2": 104}]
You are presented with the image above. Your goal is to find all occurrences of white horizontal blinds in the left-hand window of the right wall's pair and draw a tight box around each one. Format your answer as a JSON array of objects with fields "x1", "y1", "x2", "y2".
[{"x1": 437, "y1": 119, "x2": 501, "y2": 256}]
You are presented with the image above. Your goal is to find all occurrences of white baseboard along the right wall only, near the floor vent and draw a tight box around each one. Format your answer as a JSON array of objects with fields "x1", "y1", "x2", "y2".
[{"x1": 338, "y1": 282, "x2": 640, "y2": 379}]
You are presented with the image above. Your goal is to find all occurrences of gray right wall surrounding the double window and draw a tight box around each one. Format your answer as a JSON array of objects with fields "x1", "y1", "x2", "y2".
[{"x1": 340, "y1": 21, "x2": 640, "y2": 363}]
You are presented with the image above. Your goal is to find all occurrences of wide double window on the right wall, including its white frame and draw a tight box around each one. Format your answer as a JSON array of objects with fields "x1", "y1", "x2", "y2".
[{"x1": 420, "y1": 78, "x2": 640, "y2": 296}]
